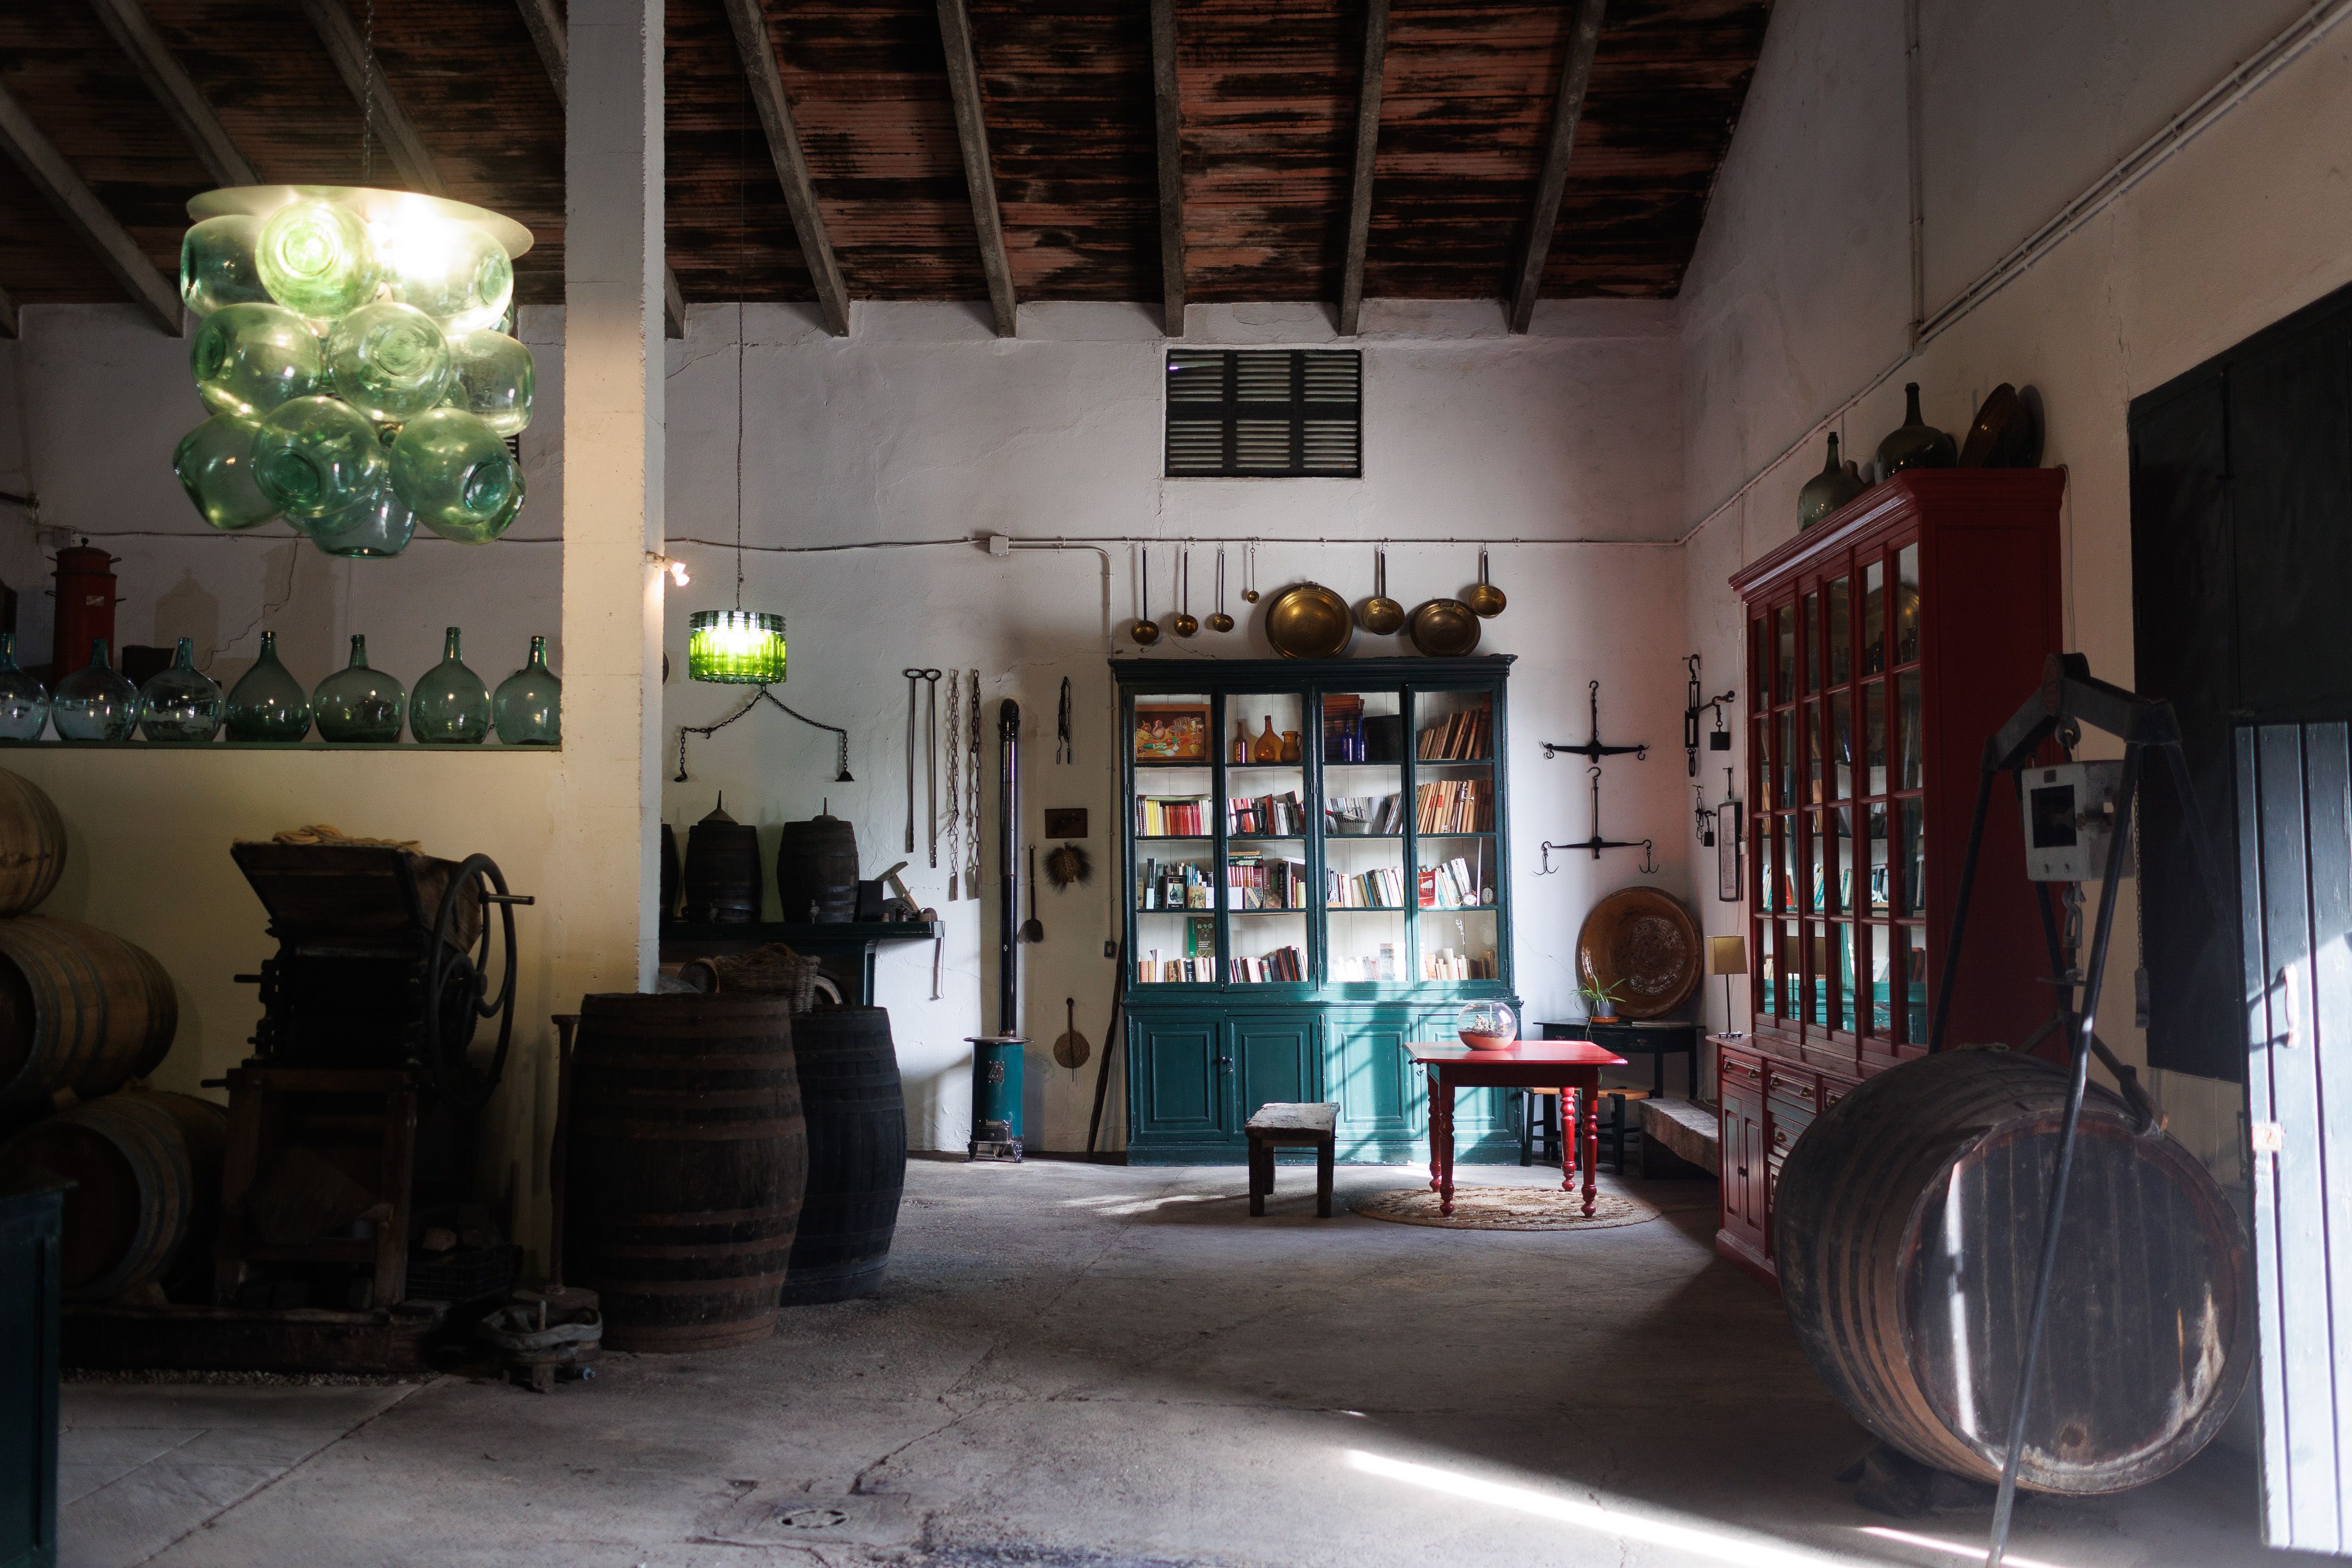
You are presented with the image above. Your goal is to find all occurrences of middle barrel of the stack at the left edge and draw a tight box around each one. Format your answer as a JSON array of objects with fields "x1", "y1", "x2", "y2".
[{"x1": 0, "y1": 914, "x2": 179, "y2": 1112}]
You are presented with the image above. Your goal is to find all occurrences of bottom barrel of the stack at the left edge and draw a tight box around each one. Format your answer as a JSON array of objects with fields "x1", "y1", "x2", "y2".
[{"x1": 0, "y1": 1088, "x2": 228, "y2": 1302}]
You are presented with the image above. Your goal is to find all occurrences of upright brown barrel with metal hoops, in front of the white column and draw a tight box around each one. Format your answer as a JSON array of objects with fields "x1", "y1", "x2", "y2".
[{"x1": 564, "y1": 992, "x2": 809, "y2": 1349}]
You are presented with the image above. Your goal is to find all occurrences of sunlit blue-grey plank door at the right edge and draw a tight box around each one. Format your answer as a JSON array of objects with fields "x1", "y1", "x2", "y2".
[{"x1": 2237, "y1": 724, "x2": 2352, "y2": 1554}]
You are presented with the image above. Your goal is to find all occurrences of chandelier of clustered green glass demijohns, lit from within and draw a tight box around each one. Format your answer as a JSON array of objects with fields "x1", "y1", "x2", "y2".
[{"x1": 172, "y1": 186, "x2": 534, "y2": 560}]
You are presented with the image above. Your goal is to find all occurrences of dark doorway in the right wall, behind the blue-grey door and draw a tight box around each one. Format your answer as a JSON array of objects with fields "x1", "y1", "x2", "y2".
[{"x1": 2131, "y1": 278, "x2": 2352, "y2": 1079}]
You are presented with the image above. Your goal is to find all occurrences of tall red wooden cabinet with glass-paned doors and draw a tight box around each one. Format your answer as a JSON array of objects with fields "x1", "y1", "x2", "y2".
[{"x1": 1717, "y1": 468, "x2": 2065, "y2": 1276}]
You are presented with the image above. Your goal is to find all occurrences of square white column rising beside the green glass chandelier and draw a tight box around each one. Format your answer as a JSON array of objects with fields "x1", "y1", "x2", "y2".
[{"x1": 546, "y1": 0, "x2": 663, "y2": 1001}]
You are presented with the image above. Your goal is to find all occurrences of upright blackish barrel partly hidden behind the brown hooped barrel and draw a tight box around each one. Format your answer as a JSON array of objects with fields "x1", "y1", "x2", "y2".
[{"x1": 783, "y1": 1006, "x2": 906, "y2": 1307}]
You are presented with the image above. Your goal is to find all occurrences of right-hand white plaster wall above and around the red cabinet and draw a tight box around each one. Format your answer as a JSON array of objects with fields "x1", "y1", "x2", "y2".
[{"x1": 1682, "y1": 0, "x2": 2352, "y2": 1173}]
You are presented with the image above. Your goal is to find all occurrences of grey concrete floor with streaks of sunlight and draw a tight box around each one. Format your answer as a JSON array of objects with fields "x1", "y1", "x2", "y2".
[{"x1": 64, "y1": 1161, "x2": 2288, "y2": 1568}]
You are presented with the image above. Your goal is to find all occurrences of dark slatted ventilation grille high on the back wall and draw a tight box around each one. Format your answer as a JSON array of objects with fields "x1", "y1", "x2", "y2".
[{"x1": 1167, "y1": 348, "x2": 1364, "y2": 480}]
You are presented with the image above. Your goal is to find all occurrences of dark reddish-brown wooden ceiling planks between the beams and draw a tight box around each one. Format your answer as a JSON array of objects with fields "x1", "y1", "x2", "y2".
[{"x1": 0, "y1": 0, "x2": 1771, "y2": 319}]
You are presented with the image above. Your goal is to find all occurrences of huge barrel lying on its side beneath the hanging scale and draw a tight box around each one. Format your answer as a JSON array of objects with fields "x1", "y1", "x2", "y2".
[{"x1": 1773, "y1": 1051, "x2": 2253, "y2": 1493}]
